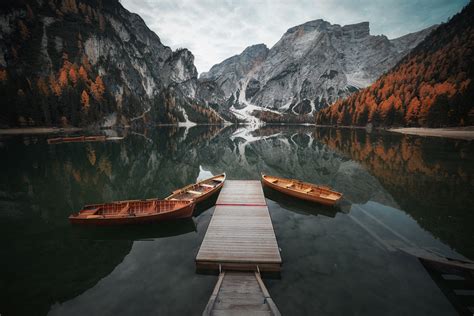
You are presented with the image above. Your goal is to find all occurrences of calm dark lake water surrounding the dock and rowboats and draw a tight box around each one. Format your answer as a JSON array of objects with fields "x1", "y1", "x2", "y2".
[{"x1": 0, "y1": 127, "x2": 474, "y2": 316}]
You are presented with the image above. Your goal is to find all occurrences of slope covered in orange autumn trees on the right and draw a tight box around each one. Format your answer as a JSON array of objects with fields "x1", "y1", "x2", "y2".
[{"x1": 317, "y1": 1, "x2": 474, "y2": 127}]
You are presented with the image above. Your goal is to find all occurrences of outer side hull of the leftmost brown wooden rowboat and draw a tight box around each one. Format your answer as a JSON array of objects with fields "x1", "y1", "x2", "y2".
[{"x1": 69, "y1": 203, "x2": 195, "y2": 226}]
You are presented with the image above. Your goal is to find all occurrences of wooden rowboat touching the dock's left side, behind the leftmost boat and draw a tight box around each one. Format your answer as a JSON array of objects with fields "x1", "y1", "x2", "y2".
[{"x1": 165, "y1": 173, "x2": 226, "y2": 203}]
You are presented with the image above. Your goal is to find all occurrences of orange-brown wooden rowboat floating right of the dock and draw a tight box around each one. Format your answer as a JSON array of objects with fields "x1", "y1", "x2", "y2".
[{"x1": 262, "y1": 174, "x2": 342, "y2": 206}]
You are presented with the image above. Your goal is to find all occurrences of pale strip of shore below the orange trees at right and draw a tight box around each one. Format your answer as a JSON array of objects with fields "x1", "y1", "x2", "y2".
[{"x1": 387, "y1": 126, "x2": 474, "y2": 140}]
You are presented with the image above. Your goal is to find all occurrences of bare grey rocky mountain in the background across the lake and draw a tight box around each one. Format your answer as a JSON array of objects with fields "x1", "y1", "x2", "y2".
[{"x1": 200, "y1": 20, "x2": 433, "y2": 120}]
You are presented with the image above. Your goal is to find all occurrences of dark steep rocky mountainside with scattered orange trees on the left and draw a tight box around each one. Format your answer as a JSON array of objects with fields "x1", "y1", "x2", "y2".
[{"x1": 0, "y1": 0, "x2": 222, "y2": 127}]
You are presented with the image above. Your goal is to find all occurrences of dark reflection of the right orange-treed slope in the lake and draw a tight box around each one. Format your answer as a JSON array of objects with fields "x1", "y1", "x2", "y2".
[{"x1": 316, "y1": 129, "x2": 474, "y2": 259}]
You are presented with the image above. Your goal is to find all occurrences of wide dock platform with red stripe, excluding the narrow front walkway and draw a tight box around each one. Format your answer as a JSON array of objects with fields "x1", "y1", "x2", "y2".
[{"x1": 196, "y1": 180, "x2": 281, "y2": 271}]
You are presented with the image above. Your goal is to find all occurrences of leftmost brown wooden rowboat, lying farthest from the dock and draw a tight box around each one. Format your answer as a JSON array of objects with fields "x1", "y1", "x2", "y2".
[{"x1": 69, "y1": 199, "x2": 195, "y2": 225}]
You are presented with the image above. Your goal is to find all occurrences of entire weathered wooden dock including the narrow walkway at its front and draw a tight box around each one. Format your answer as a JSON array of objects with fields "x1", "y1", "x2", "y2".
[{"x1": 196, "y1": 180, "x2": 281, "y2": 315}]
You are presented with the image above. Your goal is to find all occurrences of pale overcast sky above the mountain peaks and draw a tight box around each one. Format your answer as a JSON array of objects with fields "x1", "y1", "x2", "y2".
[{"x1": 121, "y1": 0, "x2": 469, "y2": 73}]
